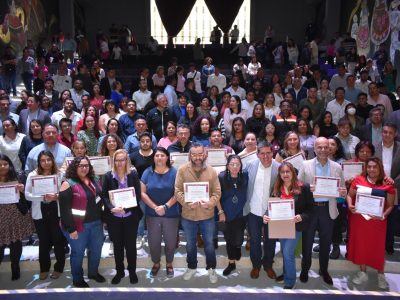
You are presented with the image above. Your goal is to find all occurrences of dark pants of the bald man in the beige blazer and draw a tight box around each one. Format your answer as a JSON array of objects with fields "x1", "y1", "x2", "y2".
[{"x1": 301, "y1": 203, "x2": 334, "y2": 272}]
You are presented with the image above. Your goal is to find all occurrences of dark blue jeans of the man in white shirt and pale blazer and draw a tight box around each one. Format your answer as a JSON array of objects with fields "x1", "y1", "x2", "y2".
[{"x1": 248, "y1": 213, "x2": 276, "y2": 270}]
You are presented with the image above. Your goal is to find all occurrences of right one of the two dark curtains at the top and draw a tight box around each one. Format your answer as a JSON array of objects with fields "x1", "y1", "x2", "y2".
[{"x1": 205, "y1": 0, "x2": 243, "y2": 44}]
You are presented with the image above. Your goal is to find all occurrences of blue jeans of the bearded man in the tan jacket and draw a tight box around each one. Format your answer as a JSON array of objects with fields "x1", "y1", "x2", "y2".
[{"x1": 181, "y1": 218, "x2": 217, "y2": 270}]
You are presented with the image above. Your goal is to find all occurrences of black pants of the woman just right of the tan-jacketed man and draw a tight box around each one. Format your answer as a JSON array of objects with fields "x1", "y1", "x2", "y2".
[{"x1": 224, "y1": 217, "x2": 246, "y2": 260}]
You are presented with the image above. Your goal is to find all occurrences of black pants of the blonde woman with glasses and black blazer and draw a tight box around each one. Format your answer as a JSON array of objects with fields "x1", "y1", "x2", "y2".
[{"x1": 107, "y1": 215, "x2": 139, "y2": 273}]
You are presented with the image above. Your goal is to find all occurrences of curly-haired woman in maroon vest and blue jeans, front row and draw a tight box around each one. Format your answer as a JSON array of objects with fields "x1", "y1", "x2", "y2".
[{"x1": 58, "y1": 156, "x2": 106, "y2": 288}]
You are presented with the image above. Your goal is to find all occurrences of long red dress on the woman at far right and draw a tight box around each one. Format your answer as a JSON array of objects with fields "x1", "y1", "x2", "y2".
[{"x1": 347, "y1": 176, "x2": 395, "y2": 271}]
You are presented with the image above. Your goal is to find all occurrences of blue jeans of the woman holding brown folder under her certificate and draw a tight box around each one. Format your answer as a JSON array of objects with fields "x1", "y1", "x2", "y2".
[{"x1": 279, "y1": 231, "x2": 301, "y2": 287}]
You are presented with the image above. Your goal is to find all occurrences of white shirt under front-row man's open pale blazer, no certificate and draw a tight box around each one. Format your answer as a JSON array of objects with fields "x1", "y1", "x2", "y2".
[{"x1": 250, "y1": 162, "x2": 272, "y2": 217}]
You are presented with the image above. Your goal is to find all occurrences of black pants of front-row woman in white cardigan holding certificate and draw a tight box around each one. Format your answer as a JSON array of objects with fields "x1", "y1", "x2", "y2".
[{"x1": 34, "y1": 217, "x2": 65, "y2": 273}]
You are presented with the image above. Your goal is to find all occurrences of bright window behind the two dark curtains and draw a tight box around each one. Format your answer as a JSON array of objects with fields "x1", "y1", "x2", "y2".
[{"x1": 150, "y1": 0, "x2": 251, "y2": 44}]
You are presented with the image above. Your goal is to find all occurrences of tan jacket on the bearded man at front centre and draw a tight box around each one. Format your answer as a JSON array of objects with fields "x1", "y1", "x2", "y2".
[{"x1": 175, "y1": 162, "x2": 221, "y2": 221}]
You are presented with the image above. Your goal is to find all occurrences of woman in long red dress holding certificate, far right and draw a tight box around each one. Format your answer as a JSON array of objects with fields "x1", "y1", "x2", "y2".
[{"x1": 347, "y1": 157, "x2": 395, "y2": 290}]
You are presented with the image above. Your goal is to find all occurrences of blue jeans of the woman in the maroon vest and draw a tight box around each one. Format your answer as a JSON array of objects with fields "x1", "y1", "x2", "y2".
[{"x1": 64, "y1": 220, "x2": 104, "y2": 282}]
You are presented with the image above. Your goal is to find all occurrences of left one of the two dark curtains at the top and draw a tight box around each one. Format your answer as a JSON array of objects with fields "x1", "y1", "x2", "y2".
[{"x1": 156, "y1": 0, "x2": 196, "y2": 44}]
